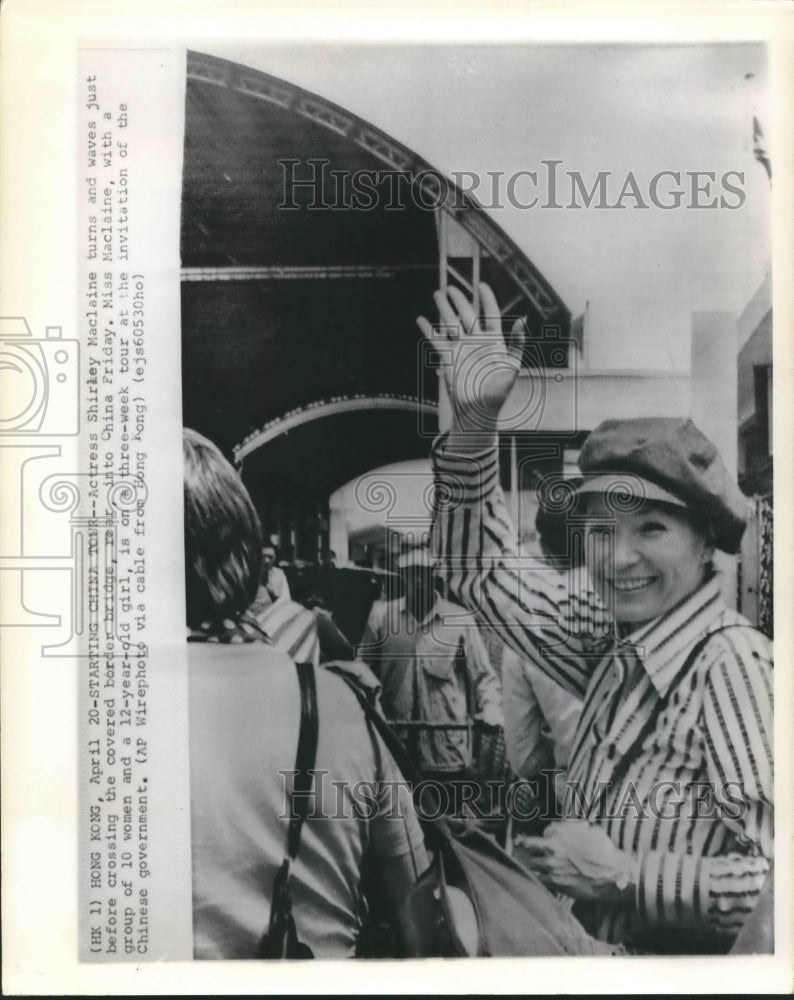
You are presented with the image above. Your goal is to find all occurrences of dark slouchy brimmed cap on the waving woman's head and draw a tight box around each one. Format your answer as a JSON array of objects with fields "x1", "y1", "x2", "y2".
[{"x1": 579, "y1": 417, "x2": 748, "y2": 552}]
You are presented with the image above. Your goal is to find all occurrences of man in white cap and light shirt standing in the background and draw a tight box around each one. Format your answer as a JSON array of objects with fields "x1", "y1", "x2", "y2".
[{"x1": 358, "y1": 546, "x2": 503, "y2": 812}]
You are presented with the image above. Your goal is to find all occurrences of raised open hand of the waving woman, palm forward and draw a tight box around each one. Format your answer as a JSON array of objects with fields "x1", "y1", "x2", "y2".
[{"x1": 417, "y1": 284, "x2": 525, "y2": 438}]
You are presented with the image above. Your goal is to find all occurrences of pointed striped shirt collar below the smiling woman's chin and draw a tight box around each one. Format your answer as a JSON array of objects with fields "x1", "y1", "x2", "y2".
[{"x1": 624, "y1": 576, "x2": 727, "y2": 697}]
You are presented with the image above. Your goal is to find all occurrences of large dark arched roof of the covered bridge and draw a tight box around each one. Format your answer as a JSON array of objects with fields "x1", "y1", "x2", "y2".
[{"x1": 181, "y1": 52, "x2": 570, "y2": 500}]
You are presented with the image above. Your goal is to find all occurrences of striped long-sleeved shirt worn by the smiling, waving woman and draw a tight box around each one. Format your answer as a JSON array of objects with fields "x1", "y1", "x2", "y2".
[{"x1": 433, "y1": 438, "x2": 773, "y2": 942}]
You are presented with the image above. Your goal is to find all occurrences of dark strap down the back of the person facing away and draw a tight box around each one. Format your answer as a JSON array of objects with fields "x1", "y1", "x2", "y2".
[{"x1": 256, "y1": 663, "x2": 320, "y2": 958}]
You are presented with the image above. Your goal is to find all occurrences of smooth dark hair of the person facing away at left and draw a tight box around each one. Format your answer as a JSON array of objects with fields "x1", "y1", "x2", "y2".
[{"x1": 182, "y1": 428, "x2": 262, "y2": 628}]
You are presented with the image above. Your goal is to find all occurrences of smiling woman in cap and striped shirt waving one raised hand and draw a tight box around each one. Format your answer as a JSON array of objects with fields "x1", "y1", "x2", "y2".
[{"x1": 418, "y1": 285, "x2": 773, "y2": 953}]
